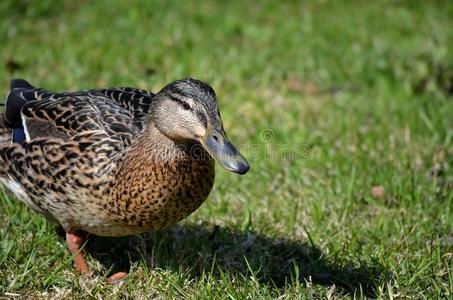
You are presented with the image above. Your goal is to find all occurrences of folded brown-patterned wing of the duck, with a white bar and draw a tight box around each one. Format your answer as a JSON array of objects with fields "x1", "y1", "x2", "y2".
[{"x1": 21, "y1": 95, "x2": 140, "y2": 144}]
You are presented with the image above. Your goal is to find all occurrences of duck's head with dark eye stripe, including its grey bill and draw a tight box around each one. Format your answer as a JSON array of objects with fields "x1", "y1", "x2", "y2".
[{"x1": 151, "y1": 78, "x2": 250, "y2": 174}]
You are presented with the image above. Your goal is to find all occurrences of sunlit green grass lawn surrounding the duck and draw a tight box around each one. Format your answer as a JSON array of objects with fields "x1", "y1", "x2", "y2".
[{"x1": 0, "y1": 0, "x2": 453, "y2": 299}]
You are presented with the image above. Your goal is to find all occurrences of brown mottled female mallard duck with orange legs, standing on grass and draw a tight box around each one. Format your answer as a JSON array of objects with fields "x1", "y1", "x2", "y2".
[{"x1": 0, "y1": 79, "x2": 249, "y2": 277}]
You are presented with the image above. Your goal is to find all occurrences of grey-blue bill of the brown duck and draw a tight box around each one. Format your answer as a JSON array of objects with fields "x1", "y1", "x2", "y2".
[{"x1": 201, "y1": 130, "x2": 250, "y2": 175}]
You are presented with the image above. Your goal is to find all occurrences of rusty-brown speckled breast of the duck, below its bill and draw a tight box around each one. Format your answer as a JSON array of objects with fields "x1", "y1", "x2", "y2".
[{"x1": 106, "y1": 158, "x2": 214, "y2": 234}]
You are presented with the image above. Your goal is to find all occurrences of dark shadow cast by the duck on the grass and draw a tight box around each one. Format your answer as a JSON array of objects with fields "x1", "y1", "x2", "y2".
[{"x1": 85, "y1": 225, "x2": 387, "y2": 296}]
